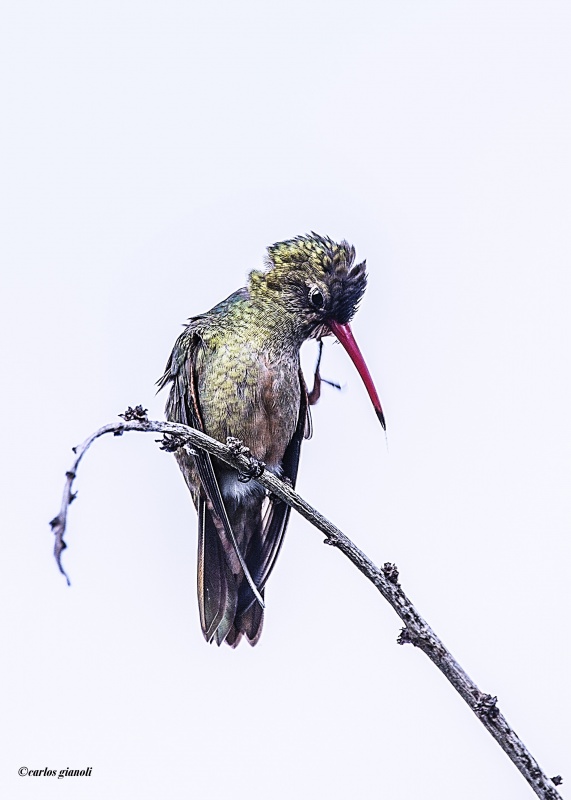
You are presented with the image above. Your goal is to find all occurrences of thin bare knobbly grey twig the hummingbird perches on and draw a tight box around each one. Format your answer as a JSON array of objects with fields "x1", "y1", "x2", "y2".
[{"x1": 50, "y1": 406, "x2": 562, "y2": 800}]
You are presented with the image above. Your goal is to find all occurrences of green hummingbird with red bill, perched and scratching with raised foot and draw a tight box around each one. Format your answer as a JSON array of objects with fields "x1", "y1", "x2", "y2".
[{"x1": 158, "y1": 232, "x2": 385, "y2": 647}]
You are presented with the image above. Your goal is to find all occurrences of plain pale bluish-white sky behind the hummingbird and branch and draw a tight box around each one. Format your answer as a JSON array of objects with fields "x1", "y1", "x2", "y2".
[{"x1": 0, "y1": 0, "x2": 571, "y2": 800}]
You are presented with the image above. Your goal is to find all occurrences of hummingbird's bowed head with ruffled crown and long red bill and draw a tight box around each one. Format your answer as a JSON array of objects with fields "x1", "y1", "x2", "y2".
[{"x1": 250, "y1": 233, "x2": 385, "y2": 428}]
